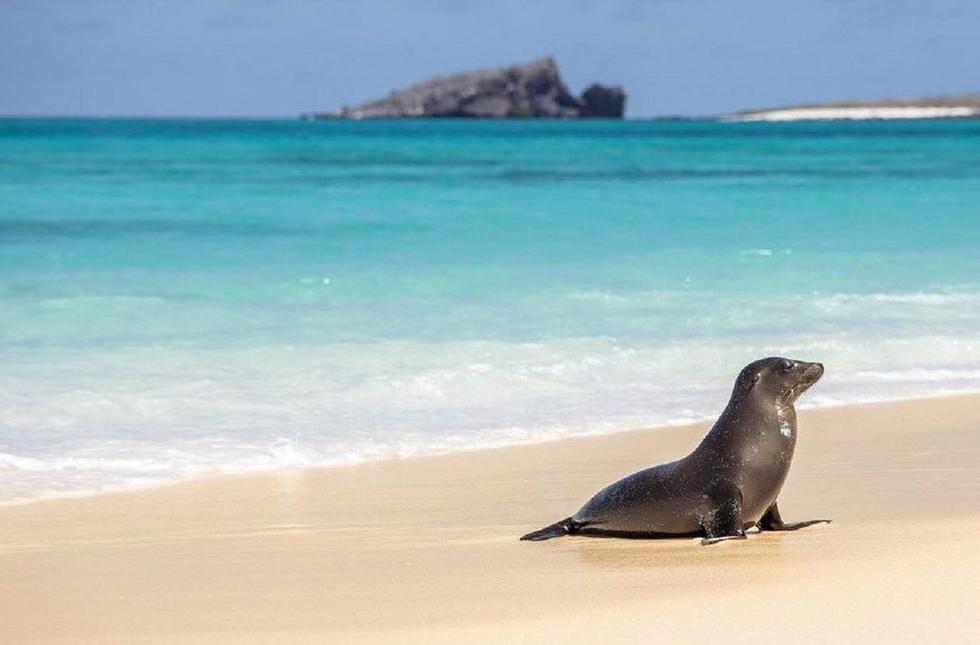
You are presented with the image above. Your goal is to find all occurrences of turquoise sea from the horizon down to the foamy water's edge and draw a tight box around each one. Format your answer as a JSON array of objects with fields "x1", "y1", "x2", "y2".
[{"x1": 0, "y1": 120, "x2": 980, "y2": 500}]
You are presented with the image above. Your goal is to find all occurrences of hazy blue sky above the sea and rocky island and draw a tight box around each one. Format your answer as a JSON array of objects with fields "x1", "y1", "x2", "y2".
[{"x1": 0, "y1": 0, "x2": 980, "y2": 117}]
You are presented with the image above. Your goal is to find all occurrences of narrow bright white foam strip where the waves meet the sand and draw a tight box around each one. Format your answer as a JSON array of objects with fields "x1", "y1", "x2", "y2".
[{"x1": 0, "y1": 374, "x2": 980, "y2": 505}]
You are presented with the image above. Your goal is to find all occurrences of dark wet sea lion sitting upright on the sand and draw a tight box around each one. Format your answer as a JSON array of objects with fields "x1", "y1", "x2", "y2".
[{"x1": 521, "y1": 357, "x2": 830, "y2": 544}]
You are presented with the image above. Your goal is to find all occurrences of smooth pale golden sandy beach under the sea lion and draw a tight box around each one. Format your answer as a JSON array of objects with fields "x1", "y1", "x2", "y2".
[{"x1": 0, "y1": 396, "x2": 980, "y2": 643}]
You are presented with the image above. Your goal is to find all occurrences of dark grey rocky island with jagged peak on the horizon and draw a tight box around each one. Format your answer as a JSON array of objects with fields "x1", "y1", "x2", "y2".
[{"x1": 304, "y1": 56, "x2": 626, "y2": 119}]
